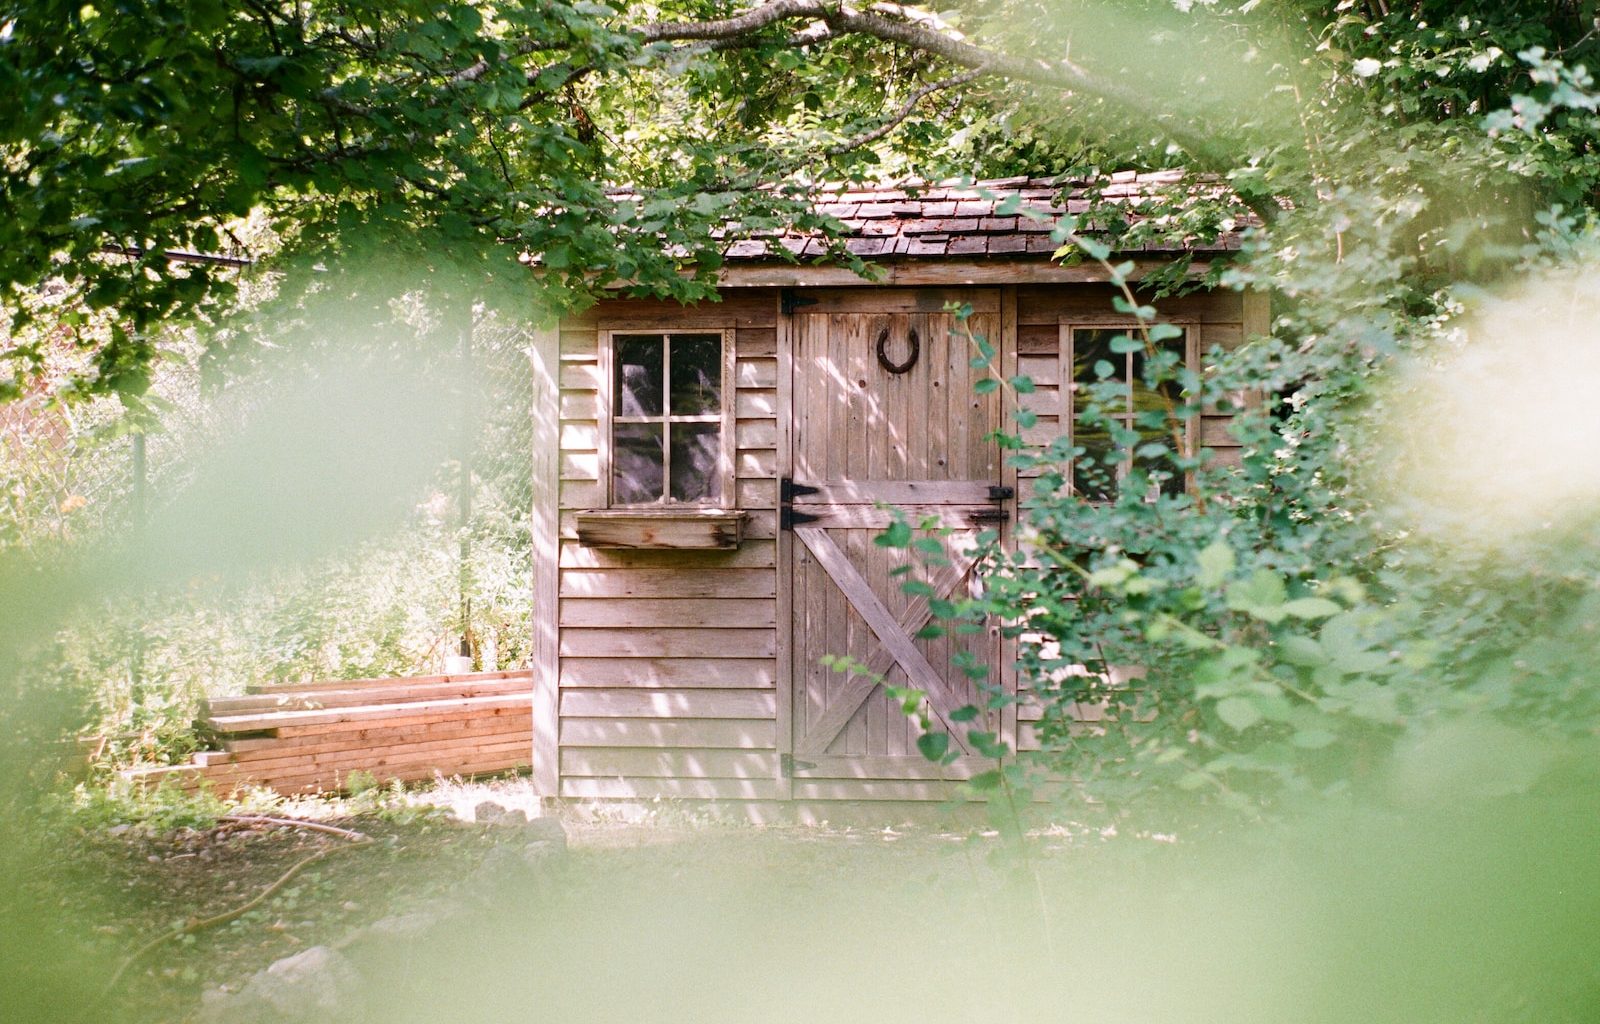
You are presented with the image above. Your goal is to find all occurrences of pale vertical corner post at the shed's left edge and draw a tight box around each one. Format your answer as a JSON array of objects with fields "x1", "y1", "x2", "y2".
[{"x1": 528, "y1": 323, "x2": 562, "y2": 798}]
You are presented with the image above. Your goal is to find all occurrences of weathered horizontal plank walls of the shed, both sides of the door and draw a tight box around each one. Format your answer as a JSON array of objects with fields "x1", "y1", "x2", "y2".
[{"x1": 550, "y1": 285, "x2": 1267, "y2": 802}]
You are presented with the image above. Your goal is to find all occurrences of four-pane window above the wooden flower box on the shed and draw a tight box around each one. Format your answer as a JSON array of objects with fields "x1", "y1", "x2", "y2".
[{"x1": 605, "y1": 331, "x2": 731, "y2": 507}]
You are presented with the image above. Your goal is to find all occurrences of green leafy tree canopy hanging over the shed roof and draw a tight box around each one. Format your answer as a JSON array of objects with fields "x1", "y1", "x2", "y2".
[{"x1": 0, "y1": 0, "x2": 1595, "y2": 394}]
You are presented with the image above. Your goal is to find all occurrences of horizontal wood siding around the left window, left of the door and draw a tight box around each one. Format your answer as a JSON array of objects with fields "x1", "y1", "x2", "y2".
[{"x1": 560, "y1": 291, "x2": 779, "y2": 800}]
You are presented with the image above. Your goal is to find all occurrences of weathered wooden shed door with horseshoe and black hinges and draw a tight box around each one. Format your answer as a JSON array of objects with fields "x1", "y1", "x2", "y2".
[{"x1": 784, "y1": 294, "x2": 1005, "y2": 797}]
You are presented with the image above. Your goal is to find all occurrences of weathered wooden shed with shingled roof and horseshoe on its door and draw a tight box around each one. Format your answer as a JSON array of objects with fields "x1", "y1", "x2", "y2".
[{"x1": 533, "y1": 174, "x2": 1267, "y2": 813}]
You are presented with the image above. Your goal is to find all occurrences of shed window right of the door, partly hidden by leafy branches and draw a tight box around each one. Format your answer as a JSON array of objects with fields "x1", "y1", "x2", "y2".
[{"x1": 1067, "y1": 323, "x2": 1194, "y2": 501}]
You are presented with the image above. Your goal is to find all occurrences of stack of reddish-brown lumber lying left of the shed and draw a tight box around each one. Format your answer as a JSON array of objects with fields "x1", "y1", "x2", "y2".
[{"x1": 123, "y1": 670, "x2": 533, "y2": 794}]
